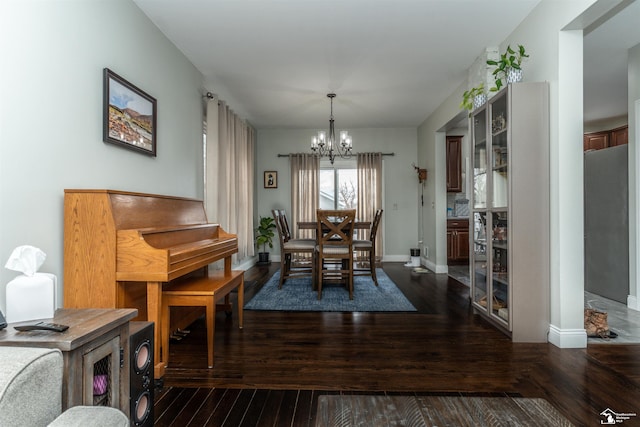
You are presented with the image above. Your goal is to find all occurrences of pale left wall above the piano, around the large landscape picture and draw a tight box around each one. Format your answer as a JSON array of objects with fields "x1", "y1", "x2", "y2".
[{"x1": 0, "y1": 0, "x2": 203, "y2": 309}]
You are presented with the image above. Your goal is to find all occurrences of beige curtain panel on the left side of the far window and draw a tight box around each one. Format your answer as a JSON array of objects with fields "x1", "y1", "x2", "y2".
[{"x1": 289, "y1": 153, "x2": 320, "y2": 238}]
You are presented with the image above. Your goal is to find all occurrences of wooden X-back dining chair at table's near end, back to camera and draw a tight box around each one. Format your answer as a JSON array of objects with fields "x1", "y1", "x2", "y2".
[{"x1": 316, "y1": 209, "x2": 356, "y2": 299}]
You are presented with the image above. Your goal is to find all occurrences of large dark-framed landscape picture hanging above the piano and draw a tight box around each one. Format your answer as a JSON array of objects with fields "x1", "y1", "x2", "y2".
[{"x1": 102, "y1": 68, "x2": 158, "y2": 157}]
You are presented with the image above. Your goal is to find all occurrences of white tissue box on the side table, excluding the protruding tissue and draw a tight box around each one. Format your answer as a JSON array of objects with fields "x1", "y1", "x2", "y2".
[{"x1": 6, "y1": 273, "x2": 57, "y2": 323}]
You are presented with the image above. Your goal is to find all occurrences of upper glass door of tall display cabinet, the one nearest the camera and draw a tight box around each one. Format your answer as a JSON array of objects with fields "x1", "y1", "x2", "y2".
[{"x1": 491, "y1": 92, "x2": 509, "y2": 208}]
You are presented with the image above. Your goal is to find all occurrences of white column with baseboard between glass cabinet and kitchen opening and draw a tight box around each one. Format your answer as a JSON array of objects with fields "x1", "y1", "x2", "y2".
[{"x1": 549, "y1": 30, "x2": 587, "y2": 348}]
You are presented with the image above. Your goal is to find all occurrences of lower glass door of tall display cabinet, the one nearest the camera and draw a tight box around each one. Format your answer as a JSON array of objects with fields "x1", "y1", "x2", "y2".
[{"x1": 491, "y1": 211, "x2": 509, "y2": 322}]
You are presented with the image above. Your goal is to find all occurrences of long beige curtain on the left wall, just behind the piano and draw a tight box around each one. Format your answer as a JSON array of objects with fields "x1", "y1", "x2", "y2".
[{"x1": 205, "y1": 99, "x2": 255, "y2": 263}]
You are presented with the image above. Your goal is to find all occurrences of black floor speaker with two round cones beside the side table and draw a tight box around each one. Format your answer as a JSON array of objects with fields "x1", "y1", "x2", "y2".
[{"x1": 129, "y1": 322, "x2": 154, "y2": 427}]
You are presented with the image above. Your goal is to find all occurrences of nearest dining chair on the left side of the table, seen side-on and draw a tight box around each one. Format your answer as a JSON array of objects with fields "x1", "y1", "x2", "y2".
[{"x1": 271, "y1": 209, "x2": 316, "y2": 289}]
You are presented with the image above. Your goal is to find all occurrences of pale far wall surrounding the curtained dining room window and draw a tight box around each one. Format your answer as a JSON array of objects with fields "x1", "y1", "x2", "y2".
[{"x1": 256, "y1": 128, "x2": 420, "y2": 261}]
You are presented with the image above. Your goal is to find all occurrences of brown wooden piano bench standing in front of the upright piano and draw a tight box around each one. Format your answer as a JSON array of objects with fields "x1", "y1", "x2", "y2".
[{"x1": 161, "y1": 270, "x2": 244, "y2": 368}]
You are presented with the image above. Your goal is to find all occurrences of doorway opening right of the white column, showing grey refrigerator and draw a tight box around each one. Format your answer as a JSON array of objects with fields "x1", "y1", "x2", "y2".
[{"x1": 583, "y1": 1, "x2": 640, "y2": 343}]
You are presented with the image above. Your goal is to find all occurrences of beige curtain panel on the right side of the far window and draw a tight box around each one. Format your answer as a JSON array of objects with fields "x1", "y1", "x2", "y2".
[{"x1": 357, "y1": 153, "x2": 384, "y2": 259}]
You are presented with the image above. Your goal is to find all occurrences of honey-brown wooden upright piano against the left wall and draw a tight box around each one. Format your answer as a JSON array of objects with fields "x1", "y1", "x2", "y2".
[{"x1": 64, "y1": 189, "x2": 238, "y2": 378}]
